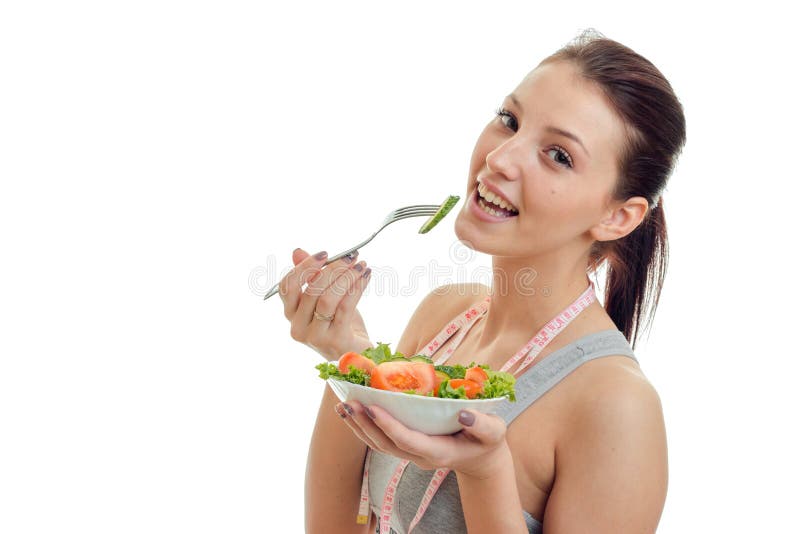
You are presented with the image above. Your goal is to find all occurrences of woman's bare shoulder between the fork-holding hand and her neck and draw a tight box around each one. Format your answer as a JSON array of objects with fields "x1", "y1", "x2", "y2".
[{"x1": 398, "y1": 283, "x2": 490, "y2": 354}]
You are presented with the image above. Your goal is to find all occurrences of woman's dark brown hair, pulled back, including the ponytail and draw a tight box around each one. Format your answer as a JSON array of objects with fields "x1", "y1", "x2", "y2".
[{"x1": 542, "y1": 29, "x2": 686, "y2": 346}]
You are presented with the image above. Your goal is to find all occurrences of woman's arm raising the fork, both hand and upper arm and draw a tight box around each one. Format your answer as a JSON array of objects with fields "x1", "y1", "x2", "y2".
[{"x1": 280, "y1": 249, "x2": 371, "y2": 534}]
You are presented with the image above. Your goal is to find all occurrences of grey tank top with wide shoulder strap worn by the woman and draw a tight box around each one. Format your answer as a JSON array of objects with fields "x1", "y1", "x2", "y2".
[{"x1": 369, "y1": 330, "x2": 636, "y2": 534}]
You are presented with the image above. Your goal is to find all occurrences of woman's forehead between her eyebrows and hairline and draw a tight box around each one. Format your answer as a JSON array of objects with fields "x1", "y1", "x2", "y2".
[{"x1": 514, "y1": 61, "x2": 625, "y2": 163}]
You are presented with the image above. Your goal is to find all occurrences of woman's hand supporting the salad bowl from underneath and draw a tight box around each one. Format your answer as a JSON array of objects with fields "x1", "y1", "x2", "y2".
[{"x1": 336, "y1": 401, "x2": 508, "y2": 478}]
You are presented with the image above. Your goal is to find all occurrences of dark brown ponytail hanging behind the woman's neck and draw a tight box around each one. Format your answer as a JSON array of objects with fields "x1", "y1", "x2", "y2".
[{"x1": 602, "y1": 198, "x2": 668, "y2": 348}]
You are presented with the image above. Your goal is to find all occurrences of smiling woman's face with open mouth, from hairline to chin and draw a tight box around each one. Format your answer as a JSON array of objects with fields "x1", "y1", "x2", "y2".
[{"x1": 455, "y1": 62, "x2": 624, "y2": 257}]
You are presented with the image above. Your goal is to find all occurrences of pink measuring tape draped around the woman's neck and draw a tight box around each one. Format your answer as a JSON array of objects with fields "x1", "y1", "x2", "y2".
[{"x1": 357, "y1": 282, "x2": 596, "y2": 534}]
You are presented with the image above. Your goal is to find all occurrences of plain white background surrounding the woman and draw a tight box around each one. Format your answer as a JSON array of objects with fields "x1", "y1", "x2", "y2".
[{"x1": 0, "y1": 0, "x2": 800, "y2": 533}]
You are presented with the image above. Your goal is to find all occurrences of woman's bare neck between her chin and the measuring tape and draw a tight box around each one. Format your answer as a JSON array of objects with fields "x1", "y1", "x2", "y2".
[{"x1": 480, "y1": 248, "x2": 589, "y2": 344}]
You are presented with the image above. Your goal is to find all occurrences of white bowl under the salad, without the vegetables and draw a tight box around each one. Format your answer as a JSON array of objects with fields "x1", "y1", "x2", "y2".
[{"x1": 328, "y1": 378, "x2": 508, "y2": 435}]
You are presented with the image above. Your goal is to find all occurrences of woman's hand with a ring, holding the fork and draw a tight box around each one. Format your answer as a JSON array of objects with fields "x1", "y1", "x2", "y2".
[{"x1": 279, "y1": 248, "x2": 372, "y2": 360}]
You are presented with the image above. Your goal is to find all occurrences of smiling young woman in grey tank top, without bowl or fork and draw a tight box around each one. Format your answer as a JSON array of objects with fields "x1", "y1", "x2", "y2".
[{"x1": 281, "y1": 32, "x2": 685, "y2": 534}]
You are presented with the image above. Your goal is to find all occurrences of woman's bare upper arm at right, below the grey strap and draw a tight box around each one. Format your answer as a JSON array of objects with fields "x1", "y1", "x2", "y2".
[{"x1": 544, "y1": 375, "x2": 667, "y2": 534}]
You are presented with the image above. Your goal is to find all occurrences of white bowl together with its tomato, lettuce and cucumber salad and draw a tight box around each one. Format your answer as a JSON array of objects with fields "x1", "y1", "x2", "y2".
[{"x1": 316, "y1": 343, "x2": 515, "y2": 435}]
